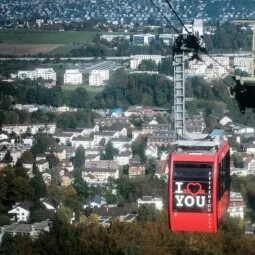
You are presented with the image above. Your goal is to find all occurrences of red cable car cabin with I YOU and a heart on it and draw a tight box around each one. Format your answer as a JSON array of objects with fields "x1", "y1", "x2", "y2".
[{"x1": 168, "y1": 135, "x2": 230, "y2": 232}]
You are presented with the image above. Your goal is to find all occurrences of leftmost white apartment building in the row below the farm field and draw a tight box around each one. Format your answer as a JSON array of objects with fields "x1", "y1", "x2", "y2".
[{"x1": 18, "y1": 68, "x2": 57, "y2": 81}]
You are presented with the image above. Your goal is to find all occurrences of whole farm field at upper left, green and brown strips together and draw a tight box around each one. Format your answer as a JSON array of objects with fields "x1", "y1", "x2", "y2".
[{"x1": 0, "y1": 29, "x2": 97, "y2": 56}]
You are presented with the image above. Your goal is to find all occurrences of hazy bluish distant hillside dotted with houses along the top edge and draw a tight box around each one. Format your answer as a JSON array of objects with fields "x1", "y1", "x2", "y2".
[{"x1": 0, "y1": 0, "x2": 255, "y2": 25}]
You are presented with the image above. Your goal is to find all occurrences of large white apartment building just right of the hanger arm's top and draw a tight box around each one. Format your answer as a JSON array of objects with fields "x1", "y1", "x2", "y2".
[{"x1": 186, "y1": 55, "x2": 229, "y2": 79}]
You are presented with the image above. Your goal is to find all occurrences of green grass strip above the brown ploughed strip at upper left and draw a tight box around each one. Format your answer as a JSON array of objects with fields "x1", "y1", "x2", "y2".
[{"x1": 0, "y1": 29, "x2": 97, "y2": 44}]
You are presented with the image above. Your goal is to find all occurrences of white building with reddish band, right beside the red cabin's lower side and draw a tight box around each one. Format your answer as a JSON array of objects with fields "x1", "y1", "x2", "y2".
[{"x1": 228, "y1": 192, "x2": 245, "y2": 219}]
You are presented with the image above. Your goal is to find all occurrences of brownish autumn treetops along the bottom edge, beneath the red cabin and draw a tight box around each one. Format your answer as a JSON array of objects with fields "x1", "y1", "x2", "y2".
[{"x1": 0, "y1": 211, "x2": 255, "y2": 255}]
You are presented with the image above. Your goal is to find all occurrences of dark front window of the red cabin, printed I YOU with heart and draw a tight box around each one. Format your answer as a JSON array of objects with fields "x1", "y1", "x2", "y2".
[{"x1": 172, "y1": 163, "x2": 213, "y2": 213}]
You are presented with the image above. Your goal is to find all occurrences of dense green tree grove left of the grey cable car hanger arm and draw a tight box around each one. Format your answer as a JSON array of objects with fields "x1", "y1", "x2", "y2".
[{"x1": 95, "y1": 70, "x2": 173, "y2": 108}]
